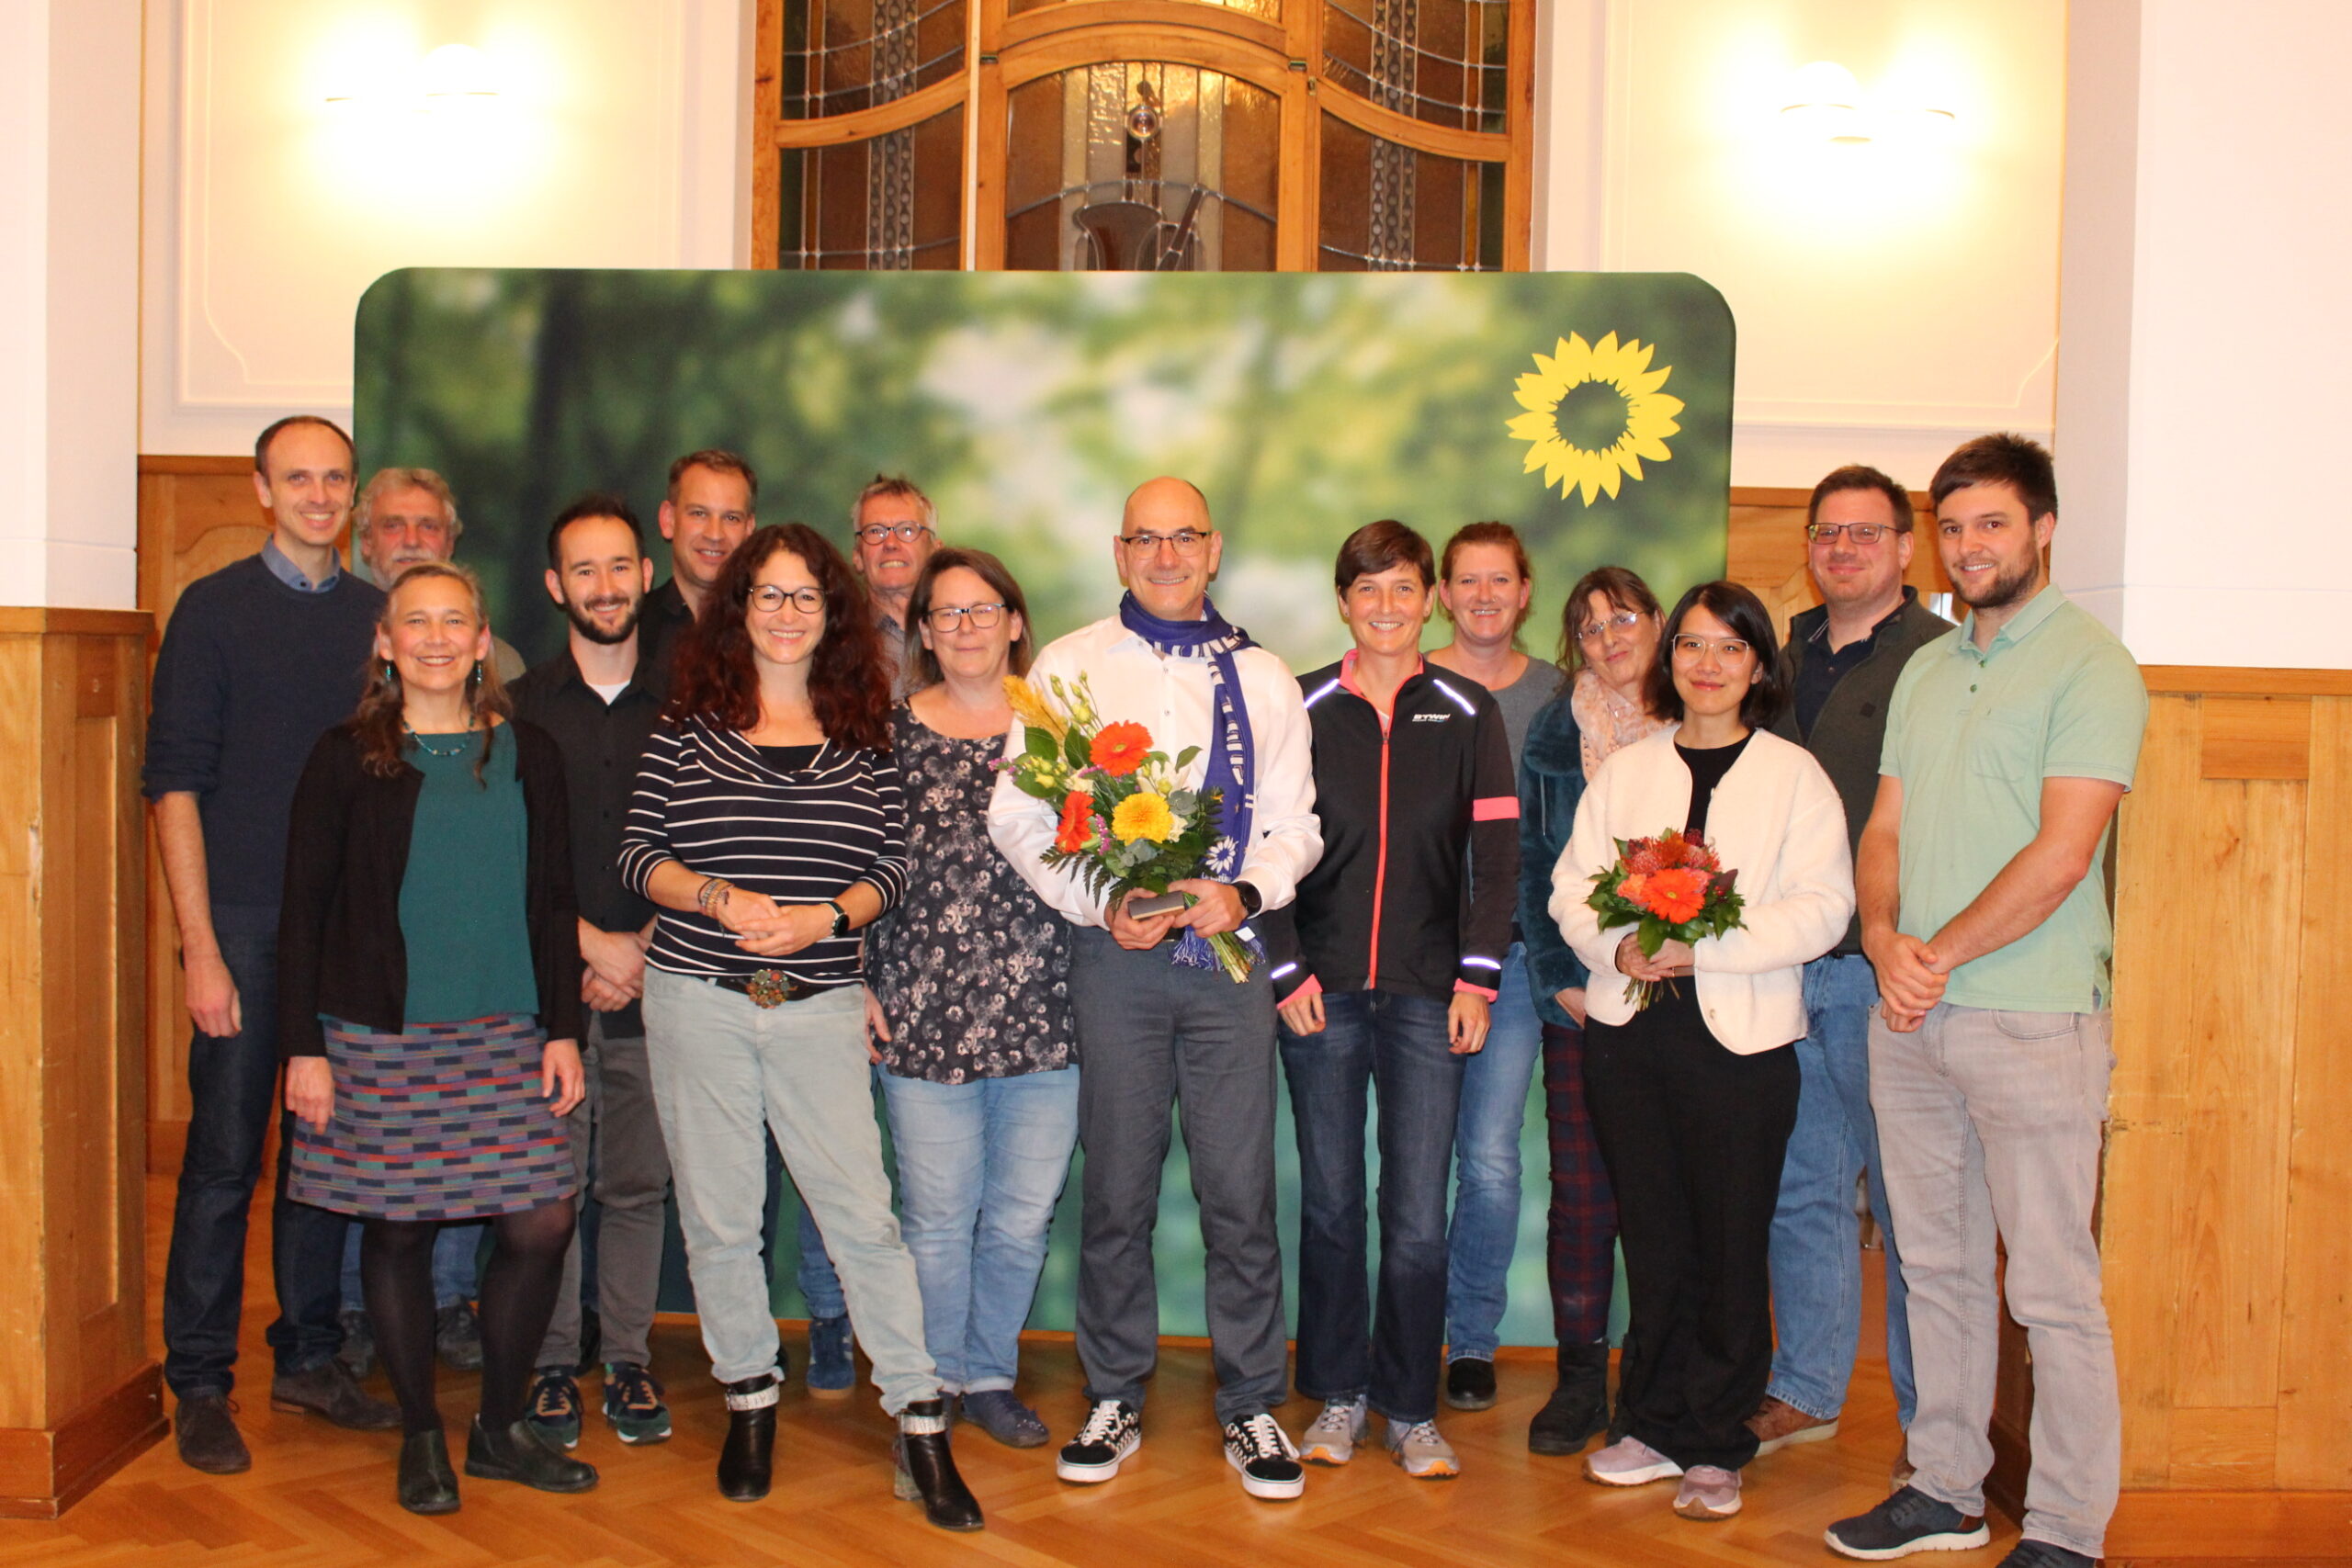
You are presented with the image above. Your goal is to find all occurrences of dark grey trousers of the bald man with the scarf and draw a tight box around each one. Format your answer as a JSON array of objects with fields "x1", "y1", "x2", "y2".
[{"x1": 1070, "y1": 929, "x2": 1289, "y2": 1422}]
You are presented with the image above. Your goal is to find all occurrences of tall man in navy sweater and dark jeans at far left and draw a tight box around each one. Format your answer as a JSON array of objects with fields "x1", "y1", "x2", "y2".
[{"x1": 143, "y1": 413, "x2": 400, "y2": 1474}]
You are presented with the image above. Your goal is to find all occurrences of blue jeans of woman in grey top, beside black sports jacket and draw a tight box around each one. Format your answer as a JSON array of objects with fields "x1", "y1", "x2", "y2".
[{"x1": 1446, "y1": 942, "x2": 1543, "y2": 1361}]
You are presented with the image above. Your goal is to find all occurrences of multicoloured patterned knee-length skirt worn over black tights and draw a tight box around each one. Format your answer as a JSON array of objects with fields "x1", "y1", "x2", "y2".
[{"x1": 287, "y1": 1013, "x2": 576, "y2": 1220}]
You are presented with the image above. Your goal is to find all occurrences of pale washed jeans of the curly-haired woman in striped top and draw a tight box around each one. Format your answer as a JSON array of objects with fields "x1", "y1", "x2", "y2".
[{"x1": 644, "y1": 968, "x2": 938, "y2": 1416}]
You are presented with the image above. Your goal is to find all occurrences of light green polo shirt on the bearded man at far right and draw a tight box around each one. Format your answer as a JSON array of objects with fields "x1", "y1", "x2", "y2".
[{"x1": 1879, "y1": 588, "x2": 2147, "y2": 1013}]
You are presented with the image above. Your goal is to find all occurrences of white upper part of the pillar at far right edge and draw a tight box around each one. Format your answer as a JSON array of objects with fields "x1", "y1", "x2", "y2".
[{"x1": 2055, "y1": 0, "x2": 2352, "y2": 670}]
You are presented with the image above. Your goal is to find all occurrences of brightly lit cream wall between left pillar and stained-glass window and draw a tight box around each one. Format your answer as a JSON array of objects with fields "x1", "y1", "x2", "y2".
[{"x1": 139, "y1": 0, "x2": 748, "y2": 454}]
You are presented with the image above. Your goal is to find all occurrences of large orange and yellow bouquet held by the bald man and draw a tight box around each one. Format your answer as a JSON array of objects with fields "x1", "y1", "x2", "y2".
[{"x1": 995, "y1": 674, "x2": 1253, "y2": 983}]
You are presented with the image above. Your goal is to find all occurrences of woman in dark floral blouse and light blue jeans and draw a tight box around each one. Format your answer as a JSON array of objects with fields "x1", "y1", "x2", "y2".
[{"x1": 868, "y1": 550, "x2": 1077, "y2": 1448}]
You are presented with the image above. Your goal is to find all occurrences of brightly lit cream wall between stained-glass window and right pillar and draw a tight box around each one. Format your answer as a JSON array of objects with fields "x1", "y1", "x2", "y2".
[{"x1": 1536, "y1": 0, "x2": 2065, "y2": 487}]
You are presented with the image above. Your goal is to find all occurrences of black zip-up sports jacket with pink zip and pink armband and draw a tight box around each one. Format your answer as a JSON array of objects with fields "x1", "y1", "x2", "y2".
[{"x1": 1256, "y1": 651, "x2": 1520, "y2": 1001}]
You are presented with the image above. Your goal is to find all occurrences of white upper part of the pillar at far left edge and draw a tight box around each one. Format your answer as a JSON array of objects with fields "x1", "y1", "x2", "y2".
[{"x1": 0, "y1": 0, "x2": 139, "y2": 609}]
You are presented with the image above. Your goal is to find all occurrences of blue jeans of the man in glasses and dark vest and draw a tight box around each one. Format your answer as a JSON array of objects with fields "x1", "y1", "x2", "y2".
[{"x1": 1769, "y1": 954, "x2": 1915, "y2": 1427}]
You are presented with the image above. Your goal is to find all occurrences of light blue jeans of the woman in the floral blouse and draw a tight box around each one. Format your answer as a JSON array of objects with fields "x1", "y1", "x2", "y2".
[{"x1": 882, "y1": 1067, "x2": 1077, "y2": 1394}]
